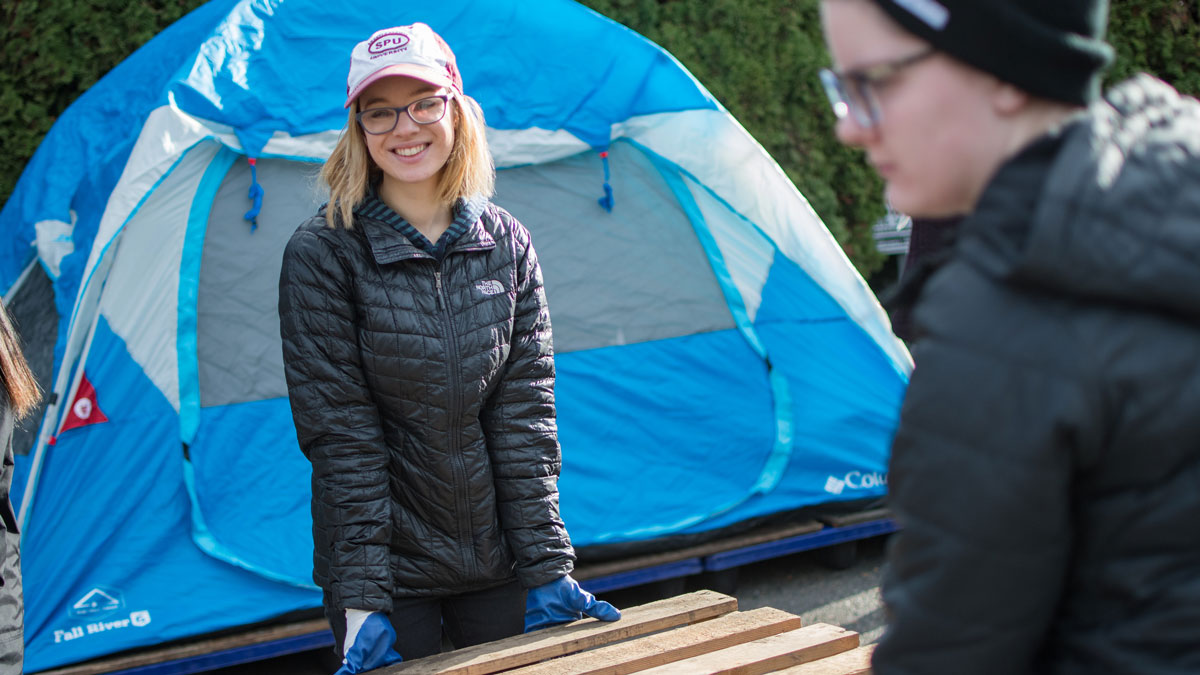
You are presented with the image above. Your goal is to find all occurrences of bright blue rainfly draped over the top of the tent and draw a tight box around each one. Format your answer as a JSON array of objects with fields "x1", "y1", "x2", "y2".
[{"x1": 0, "y1": 0, "x2": 719, "y2": 294}]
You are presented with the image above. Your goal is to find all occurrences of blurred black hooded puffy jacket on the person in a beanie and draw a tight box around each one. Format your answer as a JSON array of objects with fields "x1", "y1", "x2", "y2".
[{"x1": 875, "y1": 76, "x2": 1200, "y2": 675}]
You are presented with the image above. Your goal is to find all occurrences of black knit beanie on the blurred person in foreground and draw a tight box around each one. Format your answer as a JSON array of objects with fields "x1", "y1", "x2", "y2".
[{"x1": 874, "y1": 0, "x2": 1112, "y2": 104}]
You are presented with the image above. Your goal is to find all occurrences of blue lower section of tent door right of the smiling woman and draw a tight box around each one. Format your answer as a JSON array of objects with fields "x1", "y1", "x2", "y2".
[{"x1": 556, "y1": 330, "x2": 774, "y2": 546}]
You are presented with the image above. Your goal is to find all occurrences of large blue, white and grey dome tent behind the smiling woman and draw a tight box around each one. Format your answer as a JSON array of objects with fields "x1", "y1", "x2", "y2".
[{"x1": 0, "y1": 0, "x2": 911, "y2": 671}]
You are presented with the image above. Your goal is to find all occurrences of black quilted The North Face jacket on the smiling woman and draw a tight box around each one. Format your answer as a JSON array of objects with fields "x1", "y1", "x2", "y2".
[{"x1": 280, "y1": 198, "x2": 575, "y2": 611}]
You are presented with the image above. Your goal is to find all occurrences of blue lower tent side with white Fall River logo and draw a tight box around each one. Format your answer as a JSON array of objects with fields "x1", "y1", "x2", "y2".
[{"x1": 22, "y1": 322, "x2": 320, "y2": 673}]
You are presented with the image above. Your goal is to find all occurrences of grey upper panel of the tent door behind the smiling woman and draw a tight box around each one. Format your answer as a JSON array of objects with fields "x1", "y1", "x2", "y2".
[{"x1": 197, "y1": 144, "x2": 734, "y2": 407}]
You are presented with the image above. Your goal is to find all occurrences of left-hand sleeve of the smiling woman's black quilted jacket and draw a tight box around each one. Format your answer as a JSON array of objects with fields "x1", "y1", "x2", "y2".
[{"x1": 280, "y1": 229, "x2": 391, "y2": 611}]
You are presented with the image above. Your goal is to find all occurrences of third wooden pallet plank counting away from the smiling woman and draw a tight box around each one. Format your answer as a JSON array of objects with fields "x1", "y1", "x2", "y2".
[{"x1": 642, "y1": 623, "x2": 858, "y2": 675}]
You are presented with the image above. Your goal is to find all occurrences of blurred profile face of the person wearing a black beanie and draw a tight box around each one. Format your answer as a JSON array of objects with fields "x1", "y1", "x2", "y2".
[{"x1": 821, "y1": 0, "x2": 1010, "y2": 216}]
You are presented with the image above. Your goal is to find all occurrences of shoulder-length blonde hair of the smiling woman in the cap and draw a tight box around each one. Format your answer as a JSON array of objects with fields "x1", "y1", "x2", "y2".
[{"x1": 320, "y1": 94, "x2": 496, "y2": 229}]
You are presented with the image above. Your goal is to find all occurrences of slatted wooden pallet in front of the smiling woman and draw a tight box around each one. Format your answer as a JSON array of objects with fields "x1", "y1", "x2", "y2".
[{"x1": 373, "y1": 591, "x2": 872, "y2": 675}]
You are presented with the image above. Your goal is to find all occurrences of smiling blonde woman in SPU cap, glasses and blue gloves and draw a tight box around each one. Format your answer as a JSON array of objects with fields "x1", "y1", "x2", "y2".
[{"x1": 280, "y1": 23, "x2": 619, "y2": 673}]
